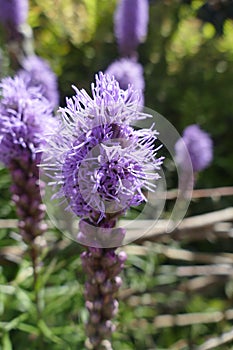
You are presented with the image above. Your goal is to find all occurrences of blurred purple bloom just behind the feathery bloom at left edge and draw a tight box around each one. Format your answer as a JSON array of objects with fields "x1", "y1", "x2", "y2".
[{"x1": 19, "y1": 55, "x2": 59, "y2": 107}]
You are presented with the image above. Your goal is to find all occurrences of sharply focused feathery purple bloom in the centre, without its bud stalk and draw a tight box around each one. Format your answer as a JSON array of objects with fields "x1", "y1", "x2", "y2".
[{"x1": 44, "y1": 73, "x2": 162, "y2": 224}]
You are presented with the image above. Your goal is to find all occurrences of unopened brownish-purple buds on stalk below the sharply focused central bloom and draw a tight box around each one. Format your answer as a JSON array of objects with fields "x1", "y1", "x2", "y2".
[{"x1": 81, "y1": 247, "x2": 127, "y2": 349}]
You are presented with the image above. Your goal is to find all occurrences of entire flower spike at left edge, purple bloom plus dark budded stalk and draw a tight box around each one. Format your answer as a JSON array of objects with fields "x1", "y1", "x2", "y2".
[{"x1": 0, "y1": 77, "x2": 55, "y2": 242}]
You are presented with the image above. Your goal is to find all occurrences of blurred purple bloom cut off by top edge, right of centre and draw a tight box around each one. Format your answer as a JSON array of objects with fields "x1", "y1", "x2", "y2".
[{"x1": 114, "y1": 0, "x2": 149, "y2": 56}]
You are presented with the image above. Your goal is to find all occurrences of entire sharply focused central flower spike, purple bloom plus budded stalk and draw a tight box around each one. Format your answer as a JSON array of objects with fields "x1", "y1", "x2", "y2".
[{"x1": 40, "y1": 73, "x2": 162, "y2": 350}]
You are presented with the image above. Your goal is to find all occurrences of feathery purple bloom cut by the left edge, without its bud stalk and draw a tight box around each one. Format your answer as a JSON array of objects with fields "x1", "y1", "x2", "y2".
[{"x1": 0, "y1": 76, "x2": 55, "y2": 166}]
